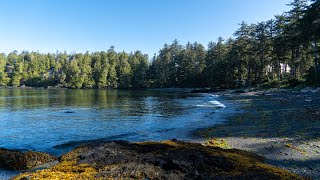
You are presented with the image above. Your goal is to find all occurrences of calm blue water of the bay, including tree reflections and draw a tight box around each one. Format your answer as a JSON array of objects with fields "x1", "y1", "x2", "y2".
[{"x1": 0, "y1": 88, "x2": 228, "y2": 155}]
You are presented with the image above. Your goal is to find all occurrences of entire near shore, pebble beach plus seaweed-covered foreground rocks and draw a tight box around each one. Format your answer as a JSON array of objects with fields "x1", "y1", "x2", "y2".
[{"x1": 0, "y1": 89, "x2": 320, "y2": 179}]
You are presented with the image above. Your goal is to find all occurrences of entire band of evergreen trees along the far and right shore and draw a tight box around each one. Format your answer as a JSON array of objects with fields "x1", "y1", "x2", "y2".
[{"x1": 0, "y1": 0, "x2": 320, "y2": 88}]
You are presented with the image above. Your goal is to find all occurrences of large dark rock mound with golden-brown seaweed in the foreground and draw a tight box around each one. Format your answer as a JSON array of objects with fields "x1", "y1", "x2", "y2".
[{"x1": 15, "y1": 141, "x2": 302, "y2": 179}]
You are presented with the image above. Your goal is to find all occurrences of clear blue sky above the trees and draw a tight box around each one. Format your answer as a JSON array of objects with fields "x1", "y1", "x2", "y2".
[{"x1": 0, "y1": 0, "x2": 291, "y2": 56}]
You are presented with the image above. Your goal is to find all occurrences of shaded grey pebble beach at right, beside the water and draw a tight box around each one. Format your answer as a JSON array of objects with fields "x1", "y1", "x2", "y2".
[{"x1": 194, "y1": 89, "x2": 320, "y2": 179}]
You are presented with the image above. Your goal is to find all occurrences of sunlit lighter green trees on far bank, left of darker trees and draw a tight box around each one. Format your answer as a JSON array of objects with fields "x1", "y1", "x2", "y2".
[{"x1": 0, "y1": 47, "x2": 149, "y2": 88}]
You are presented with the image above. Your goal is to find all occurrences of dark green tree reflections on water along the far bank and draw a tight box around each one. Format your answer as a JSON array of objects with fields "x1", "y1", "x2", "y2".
[{"x1": 0, "y1": 88, "x2": 182, "y2": 116}]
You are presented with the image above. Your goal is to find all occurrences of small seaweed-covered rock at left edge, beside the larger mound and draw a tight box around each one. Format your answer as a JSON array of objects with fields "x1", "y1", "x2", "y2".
[{"x1": 0, "y1": 148, "x2": 57, "y2": 170}]
